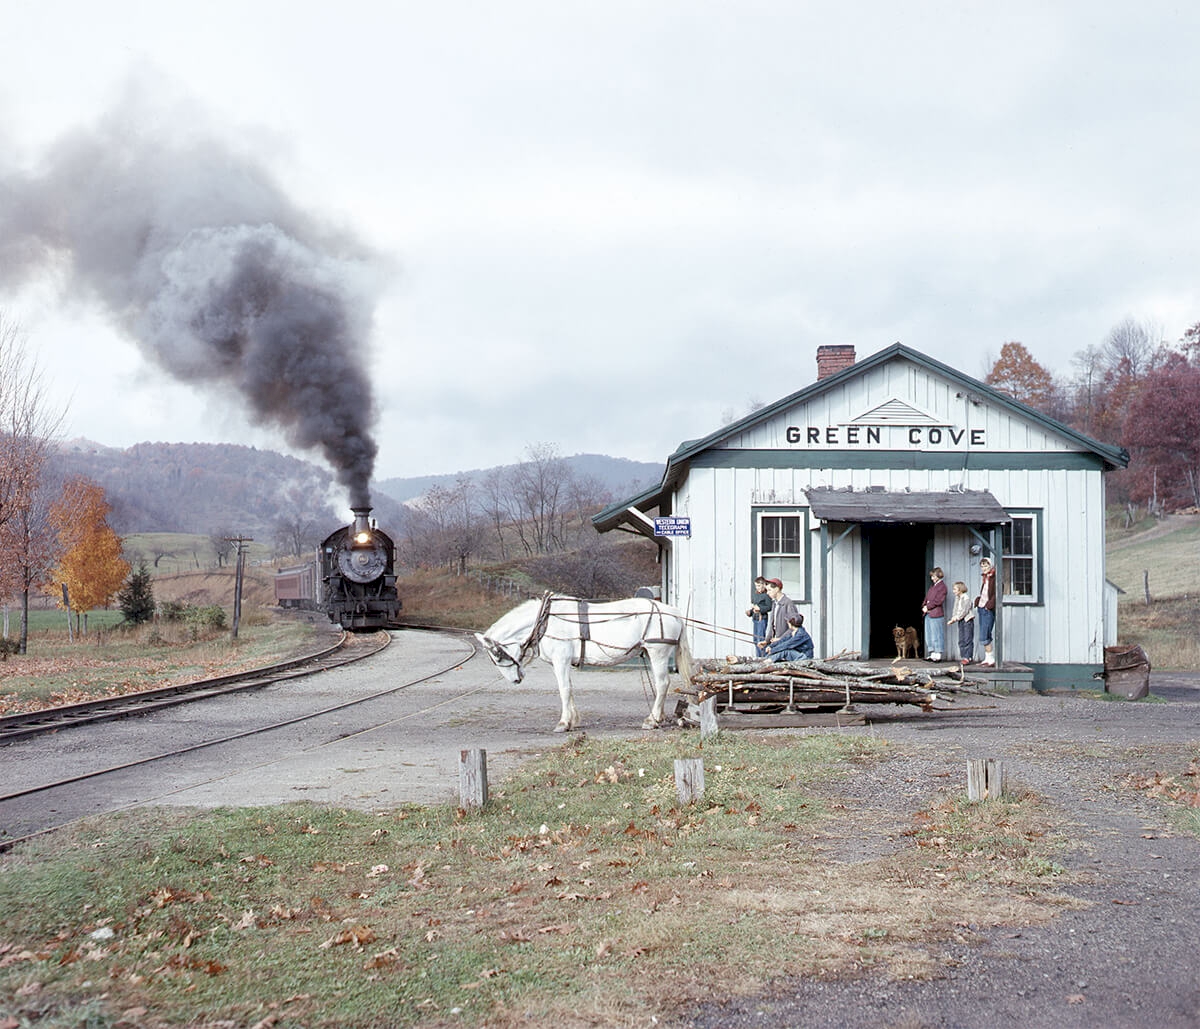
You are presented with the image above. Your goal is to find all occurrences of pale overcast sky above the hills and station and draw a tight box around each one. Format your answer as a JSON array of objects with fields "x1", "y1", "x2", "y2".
[{"x1": 0, "y1": 0, "x2": 1200, "y2": 477}]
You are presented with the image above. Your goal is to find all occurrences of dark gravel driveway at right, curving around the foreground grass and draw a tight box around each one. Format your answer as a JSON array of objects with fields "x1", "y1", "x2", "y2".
[{"x1": 684, "y1": 675, "x2": 1200, "y2": 1029}]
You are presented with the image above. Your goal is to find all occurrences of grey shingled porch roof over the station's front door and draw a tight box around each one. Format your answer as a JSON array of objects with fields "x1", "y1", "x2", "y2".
[{"x1": 804, "y1": 487, "x2": 1012, "y2": 525}]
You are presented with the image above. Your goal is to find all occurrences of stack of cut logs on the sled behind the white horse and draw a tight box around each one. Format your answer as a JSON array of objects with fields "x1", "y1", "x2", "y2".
[{"x1": 678, "y1": 657, "x2": 985, "y2": 711}]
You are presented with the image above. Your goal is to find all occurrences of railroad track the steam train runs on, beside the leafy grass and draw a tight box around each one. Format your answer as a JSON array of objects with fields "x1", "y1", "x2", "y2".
[{"x1": 0, "y1": 632, "x2": 391, "y2": 746}]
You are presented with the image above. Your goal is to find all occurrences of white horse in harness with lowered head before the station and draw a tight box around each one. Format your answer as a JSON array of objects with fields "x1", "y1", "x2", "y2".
[{"x1": 475, "y1": 594, "x2": 684, "y2": 733}]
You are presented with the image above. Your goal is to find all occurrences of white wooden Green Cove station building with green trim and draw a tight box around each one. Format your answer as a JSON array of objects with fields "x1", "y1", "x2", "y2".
[{"x1": 593, "y1": 343, "x2": 1129, "y2": 690}]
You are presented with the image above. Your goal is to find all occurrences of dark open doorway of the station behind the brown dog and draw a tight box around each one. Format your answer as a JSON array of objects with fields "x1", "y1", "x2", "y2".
[{"x1": 863, "y1": 522, "x2": 934, "y2": 657}]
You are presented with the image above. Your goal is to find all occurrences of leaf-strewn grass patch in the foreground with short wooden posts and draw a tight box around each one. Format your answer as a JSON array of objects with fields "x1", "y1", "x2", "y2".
[{"x1": 0, "y1": 734, "x2": 1064, "y2": 1027}]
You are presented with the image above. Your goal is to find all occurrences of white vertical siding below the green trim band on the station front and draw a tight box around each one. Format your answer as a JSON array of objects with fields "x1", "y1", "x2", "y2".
[{"x1": 668, "y1": 455, "x2": 1104, "y2": 664}]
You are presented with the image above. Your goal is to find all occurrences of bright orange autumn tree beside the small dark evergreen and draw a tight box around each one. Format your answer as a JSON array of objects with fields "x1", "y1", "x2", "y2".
[{"x1": 49, "y1": 477, "x2": 130, "y2": 632}]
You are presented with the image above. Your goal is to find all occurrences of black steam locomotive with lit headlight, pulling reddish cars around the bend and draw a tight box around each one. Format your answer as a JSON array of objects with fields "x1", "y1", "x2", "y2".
[{"x1": 275, "y1": 507, "x2": 401, "y2": 631}]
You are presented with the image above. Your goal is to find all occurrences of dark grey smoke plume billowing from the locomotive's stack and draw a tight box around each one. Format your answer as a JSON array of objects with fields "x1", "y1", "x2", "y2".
[{"x1": 0, "y1": 101, "x2": 382, "y2": 506}]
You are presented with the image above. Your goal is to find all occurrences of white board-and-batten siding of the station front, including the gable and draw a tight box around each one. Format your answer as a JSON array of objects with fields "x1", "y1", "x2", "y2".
[{"x1": 665, "y1": 361, "x2": 1105, "y2": 664}]
